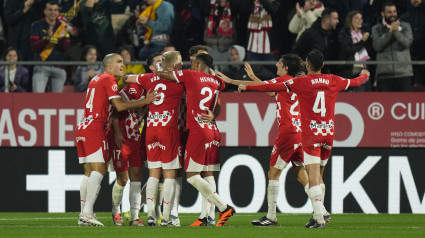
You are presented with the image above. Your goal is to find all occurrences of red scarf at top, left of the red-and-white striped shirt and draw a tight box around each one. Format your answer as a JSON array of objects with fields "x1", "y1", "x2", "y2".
[{"x1": 207, "y1": 0, "x2": 233, "y2": 37}]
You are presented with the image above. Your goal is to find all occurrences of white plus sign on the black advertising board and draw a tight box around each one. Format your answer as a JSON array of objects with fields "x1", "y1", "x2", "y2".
[{"x1": 27, "y1": 150, "x2": 84, "y2": 213}]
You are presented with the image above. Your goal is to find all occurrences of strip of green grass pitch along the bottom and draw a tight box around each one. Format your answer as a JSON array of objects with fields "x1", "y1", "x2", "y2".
[{"x1": 0, "y1": 213, "x2": 425, "y2": 238}]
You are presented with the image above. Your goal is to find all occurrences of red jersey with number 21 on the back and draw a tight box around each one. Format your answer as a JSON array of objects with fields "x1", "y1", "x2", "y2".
[{"x1": 173, "y1": 70, "x2": 225, "y2": 130}]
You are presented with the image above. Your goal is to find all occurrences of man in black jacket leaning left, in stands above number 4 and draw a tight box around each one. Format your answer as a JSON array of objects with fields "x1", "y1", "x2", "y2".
[{"x1": 294, "y1": 8, "x2": 339, "y2": 69}]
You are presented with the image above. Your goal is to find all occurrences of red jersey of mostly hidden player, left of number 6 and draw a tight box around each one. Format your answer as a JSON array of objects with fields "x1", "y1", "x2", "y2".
[{"x1": 118, "y1": 84, "x2": 146, "y2": 141}]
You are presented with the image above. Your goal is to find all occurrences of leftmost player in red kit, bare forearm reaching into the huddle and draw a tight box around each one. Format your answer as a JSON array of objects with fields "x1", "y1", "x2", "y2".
[{"x1": 75, "y1": 54, "x2": 158, "y2": 226}]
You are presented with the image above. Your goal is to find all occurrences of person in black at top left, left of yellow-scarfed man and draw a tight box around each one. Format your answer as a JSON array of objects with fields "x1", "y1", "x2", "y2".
[{"x1": 3, "y1": 0, "x2": 44, "y2": 60}]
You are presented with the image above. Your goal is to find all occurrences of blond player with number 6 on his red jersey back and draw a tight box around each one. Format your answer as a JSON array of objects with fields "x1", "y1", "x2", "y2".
[{"x1": 127, "y1": 51, "x2": 184, "y2": 226}]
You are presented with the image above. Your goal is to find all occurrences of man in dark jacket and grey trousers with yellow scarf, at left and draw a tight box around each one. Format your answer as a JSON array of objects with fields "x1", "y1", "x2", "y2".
[{"x1": 31, "y1": 0, "x2": 70, "y2": 93}]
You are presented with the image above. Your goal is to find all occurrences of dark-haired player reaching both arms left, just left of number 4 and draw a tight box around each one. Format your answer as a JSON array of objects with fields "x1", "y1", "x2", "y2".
[{"x1": 217, "y1": 54, "x2": 308, "y2": 226}]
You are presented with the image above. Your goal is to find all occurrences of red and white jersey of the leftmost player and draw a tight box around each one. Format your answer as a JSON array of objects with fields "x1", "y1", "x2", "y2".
[{"x1": 76, "y1": 73, "x2": 121, "y2": 131}]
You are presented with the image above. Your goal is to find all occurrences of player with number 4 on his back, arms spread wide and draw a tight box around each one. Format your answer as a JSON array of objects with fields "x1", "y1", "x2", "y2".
[{"x1": 239, "y1": 50, "x2": 370, "y2": 228}]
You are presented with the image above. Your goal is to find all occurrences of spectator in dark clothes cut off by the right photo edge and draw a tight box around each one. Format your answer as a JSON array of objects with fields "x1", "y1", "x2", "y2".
[{"x1": 400, "y1": 0, "x2": 425, "y2": 87}]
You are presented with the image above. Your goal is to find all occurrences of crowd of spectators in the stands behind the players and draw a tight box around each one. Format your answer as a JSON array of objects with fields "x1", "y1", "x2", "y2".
[{"x1": 0, "y1": 0, "x2": 425, "y2": 92}]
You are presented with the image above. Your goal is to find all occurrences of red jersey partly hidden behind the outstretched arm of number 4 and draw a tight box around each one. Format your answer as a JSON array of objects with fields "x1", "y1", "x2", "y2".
[{"x1": 264, "y1": 75, "x2": 301, "y2": 132}]
